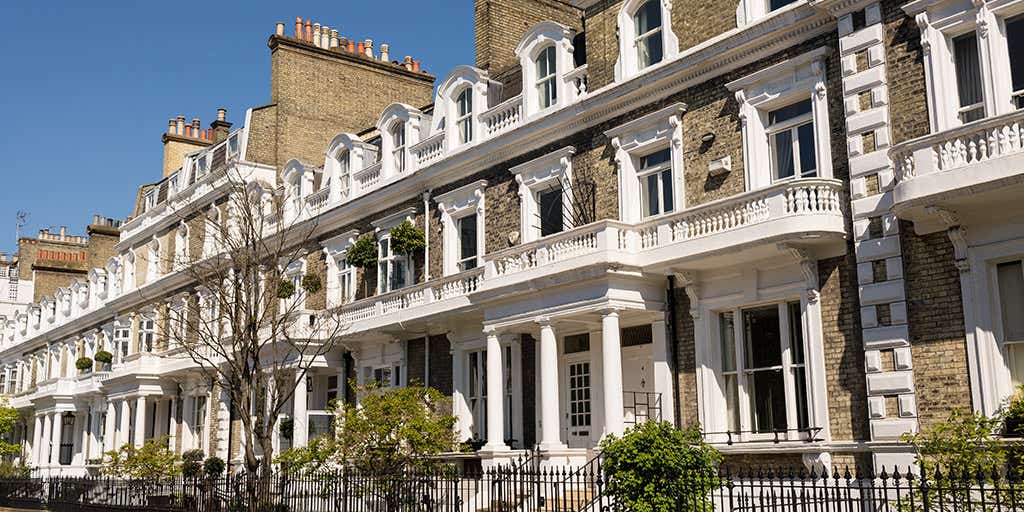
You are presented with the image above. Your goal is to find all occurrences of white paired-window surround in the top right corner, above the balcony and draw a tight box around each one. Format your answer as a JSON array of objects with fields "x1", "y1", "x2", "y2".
[{"x1": 903, "y1": 0, "x2": 1024, "y2": 133}]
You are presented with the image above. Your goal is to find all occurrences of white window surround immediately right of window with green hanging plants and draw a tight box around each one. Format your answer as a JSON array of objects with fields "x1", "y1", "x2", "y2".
[{"x1": 435, "y1": 179, "x2": 487, "y2": 275}]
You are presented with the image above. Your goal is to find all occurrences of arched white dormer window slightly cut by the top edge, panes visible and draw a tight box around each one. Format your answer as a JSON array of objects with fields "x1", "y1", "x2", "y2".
[{"x1": 615, "y1": 0, "x2": 679, "y2": 81}]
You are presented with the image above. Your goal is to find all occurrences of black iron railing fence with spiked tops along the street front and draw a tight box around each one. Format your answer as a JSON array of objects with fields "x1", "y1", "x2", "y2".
[{"x1": 0, "y1": 466, "x2": 1024, "y2": 512}]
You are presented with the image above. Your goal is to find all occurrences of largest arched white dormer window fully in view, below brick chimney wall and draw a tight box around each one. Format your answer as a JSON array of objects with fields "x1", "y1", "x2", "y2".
[{"x1": 515, "y1": 22, "x2": 578, "y2": 116}]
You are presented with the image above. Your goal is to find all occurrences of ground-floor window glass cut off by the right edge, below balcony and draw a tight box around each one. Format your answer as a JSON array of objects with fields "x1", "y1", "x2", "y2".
[{"x1": 995, "y1": 260, "x2": 1024, "y2": 389}]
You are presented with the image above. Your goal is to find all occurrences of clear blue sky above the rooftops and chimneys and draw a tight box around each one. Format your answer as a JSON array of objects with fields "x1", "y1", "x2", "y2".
[{"x1": 0, "y1": 0, "x2": 473, "y2": 256}]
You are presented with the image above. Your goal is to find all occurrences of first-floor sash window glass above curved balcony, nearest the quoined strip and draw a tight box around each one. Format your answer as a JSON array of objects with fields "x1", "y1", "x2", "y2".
[{"x1": 767, "y1": 99, "x2": 817, "y2": 180}]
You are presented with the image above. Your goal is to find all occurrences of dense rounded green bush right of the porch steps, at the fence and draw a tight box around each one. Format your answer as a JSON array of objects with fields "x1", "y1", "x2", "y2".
[{"x1": 601, "y1": 422, "x2": 722, "y2": 512}]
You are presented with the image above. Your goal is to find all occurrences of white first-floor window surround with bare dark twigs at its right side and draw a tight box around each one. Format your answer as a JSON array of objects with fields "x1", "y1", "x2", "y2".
[{"x1": 511, "y1": 146, "x2": 575, "y2": 243}]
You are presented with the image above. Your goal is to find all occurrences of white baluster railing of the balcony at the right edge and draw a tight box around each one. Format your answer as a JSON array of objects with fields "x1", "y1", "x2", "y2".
[{"x1": 890, "y1": 111, "x2": 1024, "y2": 183}]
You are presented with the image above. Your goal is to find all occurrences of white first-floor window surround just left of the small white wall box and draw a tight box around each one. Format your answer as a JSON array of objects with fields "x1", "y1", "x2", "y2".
[{"x1": 604, "y1": 103, "x2": 686, "y2": 222}]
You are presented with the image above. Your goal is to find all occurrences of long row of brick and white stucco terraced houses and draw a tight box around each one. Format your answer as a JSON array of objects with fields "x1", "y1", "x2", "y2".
[{"x1": 0, "y1": 0, "x2": 1024, "y2": 475}]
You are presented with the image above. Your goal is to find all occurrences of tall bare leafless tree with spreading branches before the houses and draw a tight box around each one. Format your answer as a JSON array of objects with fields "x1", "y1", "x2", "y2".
[{"x1": 165, "y1": 165, "x2": 345, "y2": 475}]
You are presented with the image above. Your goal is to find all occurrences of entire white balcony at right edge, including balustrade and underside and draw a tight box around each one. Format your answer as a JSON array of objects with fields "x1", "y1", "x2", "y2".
[{"x1": 889, "y1": 112, "x2": 1024, "y2": 233}]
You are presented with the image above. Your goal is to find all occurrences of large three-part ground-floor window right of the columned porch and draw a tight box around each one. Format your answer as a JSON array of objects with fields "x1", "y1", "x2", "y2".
[{"x1": 718, "y1": 301, "x2": 810, "y2": 434}]
